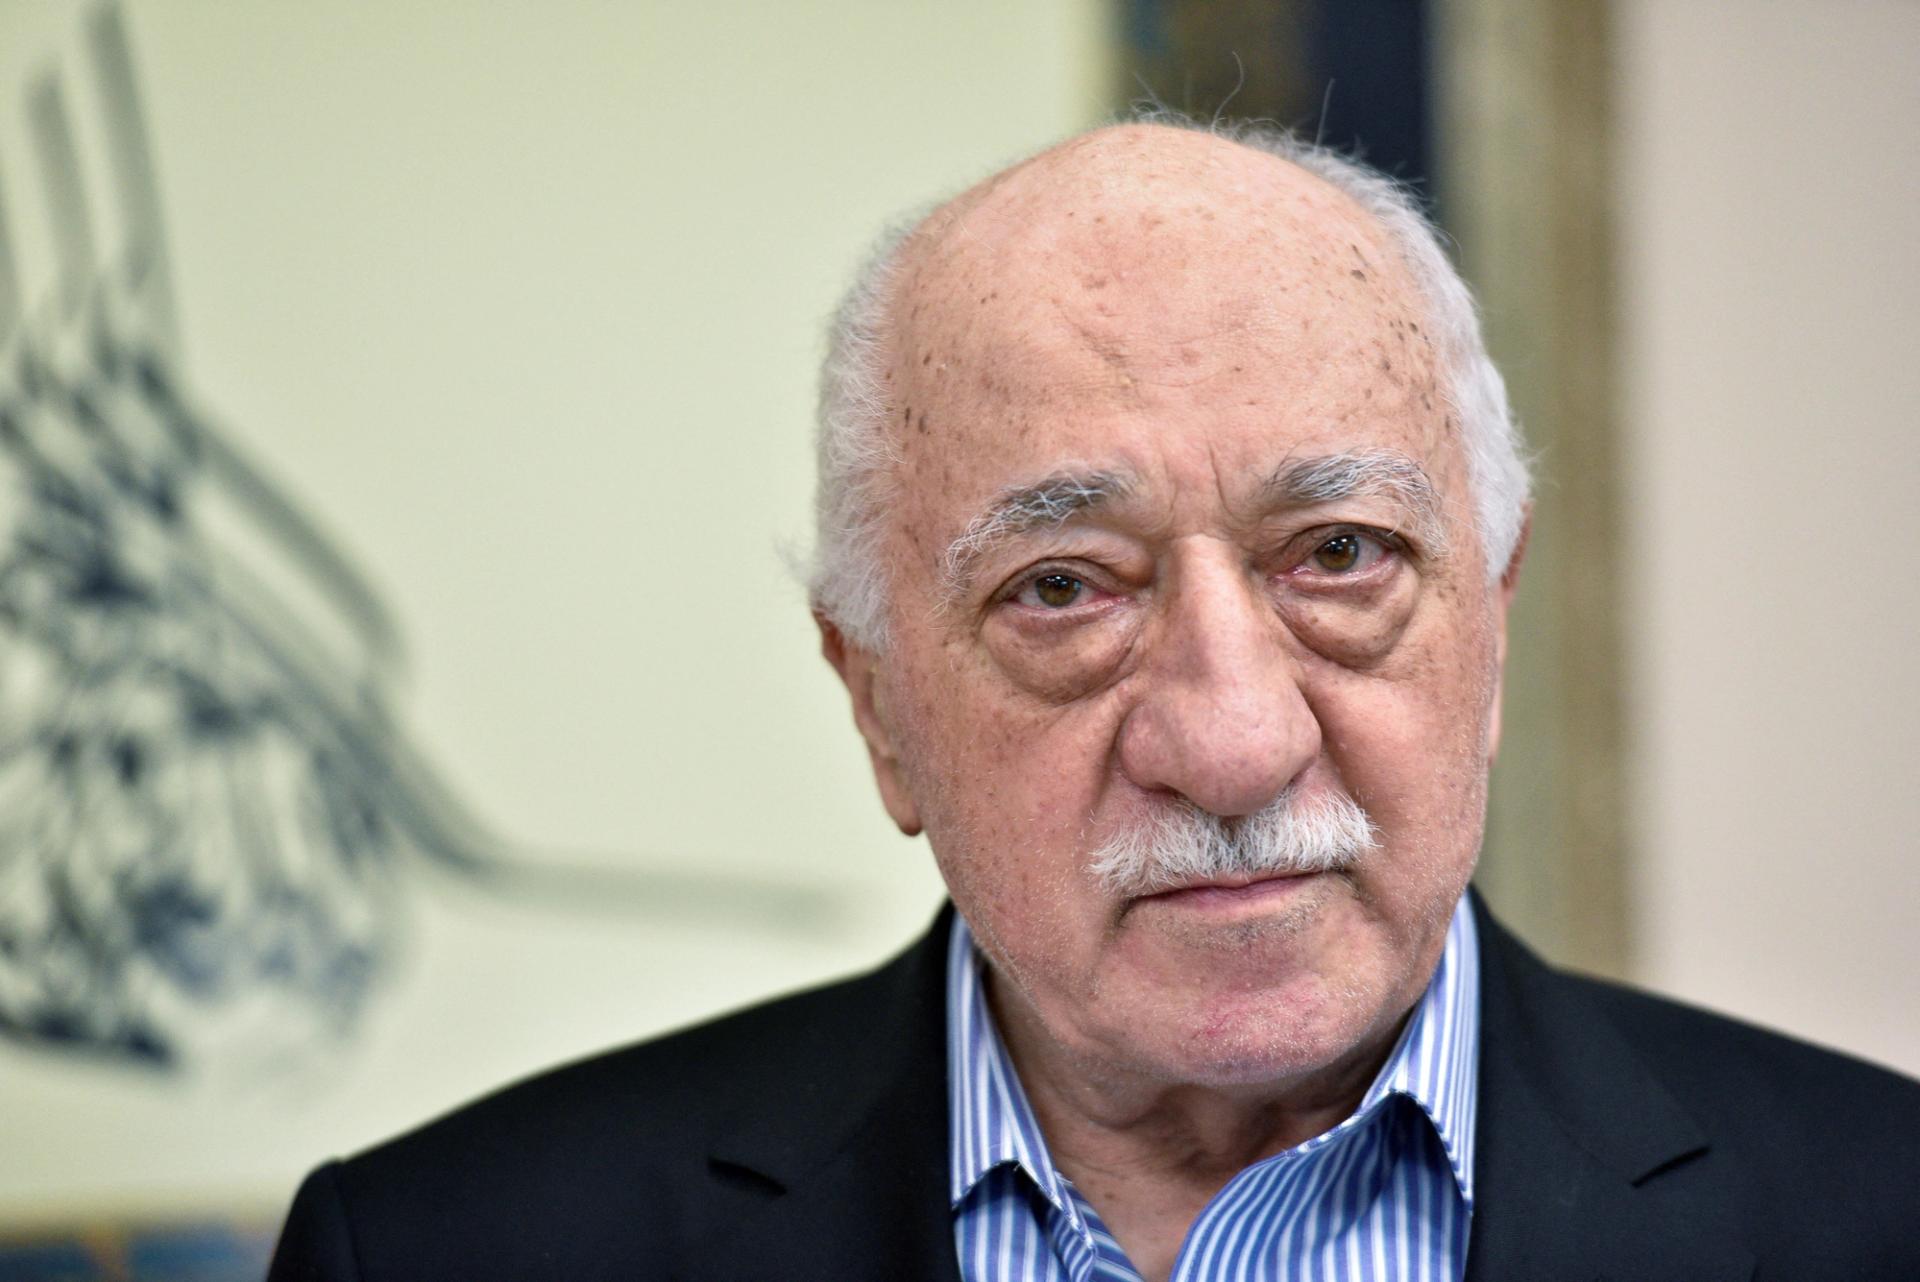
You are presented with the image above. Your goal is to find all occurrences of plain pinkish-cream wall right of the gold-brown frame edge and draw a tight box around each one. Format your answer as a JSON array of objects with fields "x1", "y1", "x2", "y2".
[{"x1": 1620, "y1": 0, "x2": 1920, "y2": 1073}]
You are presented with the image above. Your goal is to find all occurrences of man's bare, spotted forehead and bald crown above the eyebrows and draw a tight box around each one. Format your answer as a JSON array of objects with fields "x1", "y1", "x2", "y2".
[{"x1": 887, "y1": 131, "x2": 1453, "y2": 535}]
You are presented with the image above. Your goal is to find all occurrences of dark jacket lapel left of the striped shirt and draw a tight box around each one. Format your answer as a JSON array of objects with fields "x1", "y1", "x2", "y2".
[{"x1": 695, "y1": 908, "x2": 960, "y2": 1282}]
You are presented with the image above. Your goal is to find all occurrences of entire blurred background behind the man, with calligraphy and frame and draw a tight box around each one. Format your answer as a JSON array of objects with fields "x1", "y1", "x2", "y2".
[{"x1": 0, "y1": 0, "x2": 1920, "y2": 1280}]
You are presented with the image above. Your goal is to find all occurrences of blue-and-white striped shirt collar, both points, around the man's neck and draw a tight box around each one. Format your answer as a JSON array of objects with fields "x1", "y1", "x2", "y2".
[{"x1": 947, "y1": 896, "x2": 1480, "y2": 1223}]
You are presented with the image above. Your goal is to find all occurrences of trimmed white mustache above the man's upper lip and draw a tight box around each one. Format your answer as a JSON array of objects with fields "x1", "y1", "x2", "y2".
[{"x1": 1091, "y1": 787, "x2": 1380, "y2": 896}]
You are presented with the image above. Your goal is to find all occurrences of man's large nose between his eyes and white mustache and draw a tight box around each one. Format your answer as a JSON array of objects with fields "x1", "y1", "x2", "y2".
[{"x1": 1119, "y1": 564, "x2": 1321, "y2": 818}]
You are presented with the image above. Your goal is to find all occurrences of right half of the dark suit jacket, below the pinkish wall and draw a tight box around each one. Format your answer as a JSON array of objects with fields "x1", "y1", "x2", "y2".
[{"x1": 1469, "y1": 904, "x2": 1920, "y2": 1280}]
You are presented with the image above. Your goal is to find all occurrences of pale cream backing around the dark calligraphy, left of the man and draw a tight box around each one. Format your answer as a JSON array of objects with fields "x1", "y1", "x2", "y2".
[{"x1": 0, "y1": 0, "x2": 1110, "y2": 1221}]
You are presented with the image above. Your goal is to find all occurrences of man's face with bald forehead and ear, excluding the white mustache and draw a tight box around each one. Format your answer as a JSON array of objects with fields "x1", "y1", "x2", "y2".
[{"x1": 825, "y1": 131, "x2": 1503, "y2": 1084}]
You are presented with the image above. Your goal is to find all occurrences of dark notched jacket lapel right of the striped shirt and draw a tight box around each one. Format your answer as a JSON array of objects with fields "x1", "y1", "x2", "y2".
[{"x1": 1467, "y1": 896, "x2": 1753, "y2": 1282}]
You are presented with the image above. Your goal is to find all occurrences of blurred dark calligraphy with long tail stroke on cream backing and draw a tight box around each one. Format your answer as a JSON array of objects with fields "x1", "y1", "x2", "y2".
[{"x1": 0, "y1": 6, "x2": 841, "y2": 1074}]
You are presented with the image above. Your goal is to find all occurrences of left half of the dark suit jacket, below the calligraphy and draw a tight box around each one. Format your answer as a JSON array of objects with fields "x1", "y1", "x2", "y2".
[{"x1": 269, "y1": 914, "x2": 952, "y2": 1282}]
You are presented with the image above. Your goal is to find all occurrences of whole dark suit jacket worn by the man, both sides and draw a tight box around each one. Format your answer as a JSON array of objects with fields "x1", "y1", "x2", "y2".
[{"x1": 271, "y1": 900, "x2": 1920, "y2": 1282}]
